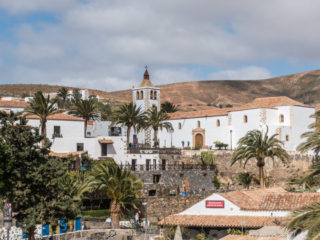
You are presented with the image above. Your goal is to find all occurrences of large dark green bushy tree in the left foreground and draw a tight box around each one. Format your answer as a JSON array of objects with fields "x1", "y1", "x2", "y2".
[{"x1": 0, "y1": 114, "x2": 79, "y2": 239}]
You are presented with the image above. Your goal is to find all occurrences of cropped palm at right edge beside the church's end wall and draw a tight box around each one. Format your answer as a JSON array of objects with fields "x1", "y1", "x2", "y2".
[{"x1": 297, "y1": 111, "x2": 320, "y2": 156}]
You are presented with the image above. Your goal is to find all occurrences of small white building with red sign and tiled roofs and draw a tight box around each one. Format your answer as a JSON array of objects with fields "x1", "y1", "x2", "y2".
[{"x1": 160, "y1": 188, "x2": 320, "y2": 239}]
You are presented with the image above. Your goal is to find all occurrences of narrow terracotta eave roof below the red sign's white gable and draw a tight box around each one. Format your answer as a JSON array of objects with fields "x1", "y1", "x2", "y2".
[{"x1": 160, "y1": 214, "x2": 284, "y2": 228}]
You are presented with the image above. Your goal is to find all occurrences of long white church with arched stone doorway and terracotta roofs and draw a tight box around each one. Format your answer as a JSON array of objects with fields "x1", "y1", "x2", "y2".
[{"x1": 159, "y1": 97, "x2": 315, "y2": 151}]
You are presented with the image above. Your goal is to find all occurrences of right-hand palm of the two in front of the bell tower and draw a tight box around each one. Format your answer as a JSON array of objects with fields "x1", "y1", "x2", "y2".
[{"x1": 146, "y1": 107, "x2": 173, "y2": 146}]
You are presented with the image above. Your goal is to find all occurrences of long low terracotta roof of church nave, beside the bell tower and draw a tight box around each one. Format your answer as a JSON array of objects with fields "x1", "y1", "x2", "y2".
[{"x1": 169, "y1": 108, "x2": 231, "y2": 120}]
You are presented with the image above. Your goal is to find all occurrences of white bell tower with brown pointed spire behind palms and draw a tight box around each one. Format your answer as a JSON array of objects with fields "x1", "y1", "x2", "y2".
[{"x1": 132, "y1": 66, "x2": 160, "y2": 145}]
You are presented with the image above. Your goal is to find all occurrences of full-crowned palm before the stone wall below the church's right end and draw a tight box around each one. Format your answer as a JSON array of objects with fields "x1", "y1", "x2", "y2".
[{"x1": 231, "y1": 128, "x2": 289, "y2": 188}]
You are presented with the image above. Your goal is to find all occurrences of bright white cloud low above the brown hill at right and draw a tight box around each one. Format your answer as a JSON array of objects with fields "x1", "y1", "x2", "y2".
[{"x1": 209, "y1": 66, "x2": 271, "y2": 80}]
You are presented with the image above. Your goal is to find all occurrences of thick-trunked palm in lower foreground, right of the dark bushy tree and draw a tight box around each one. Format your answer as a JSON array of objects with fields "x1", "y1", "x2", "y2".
[{"x1": 90, "y1": 162, "x2": 143, "y2": 228}]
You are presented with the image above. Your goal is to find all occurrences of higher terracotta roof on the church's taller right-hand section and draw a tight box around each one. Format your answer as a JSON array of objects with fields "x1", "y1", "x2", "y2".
[{"x1": 232, "y1": 96, "x2": 309, "y2": 111}]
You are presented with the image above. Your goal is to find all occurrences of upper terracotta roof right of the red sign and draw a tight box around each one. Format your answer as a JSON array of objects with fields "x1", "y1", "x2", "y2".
[{"x1": 219, "y1": 188, "x2": 320, "y2": 211}]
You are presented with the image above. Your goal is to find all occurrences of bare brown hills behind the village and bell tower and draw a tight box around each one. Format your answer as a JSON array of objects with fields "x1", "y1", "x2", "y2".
[{"x1": 0, "y1": 70, "x2": 320, "y2": 110}]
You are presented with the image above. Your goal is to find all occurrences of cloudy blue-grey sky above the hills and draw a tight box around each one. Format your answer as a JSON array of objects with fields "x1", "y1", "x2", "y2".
[{"x1": 0, "y1": 0, "x2": 320, "y2": 91}]
